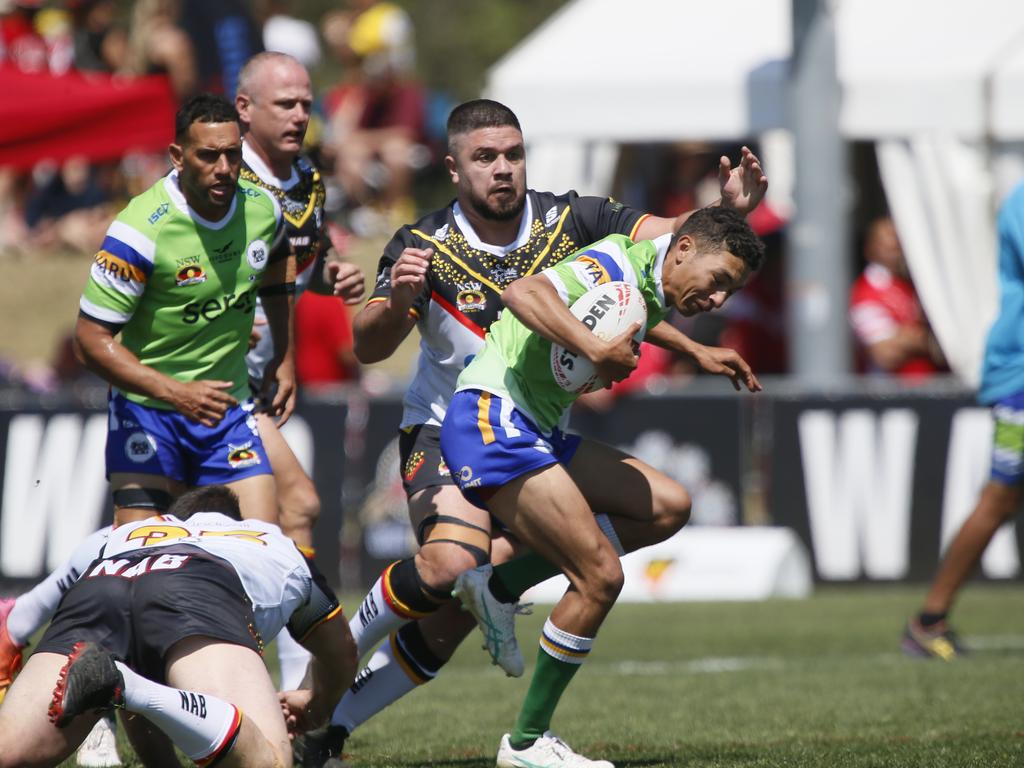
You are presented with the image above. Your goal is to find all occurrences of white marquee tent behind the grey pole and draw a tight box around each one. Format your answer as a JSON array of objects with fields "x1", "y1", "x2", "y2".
[{"x1": 486, "y1": 0, "x2": 1024, "y2": 383}]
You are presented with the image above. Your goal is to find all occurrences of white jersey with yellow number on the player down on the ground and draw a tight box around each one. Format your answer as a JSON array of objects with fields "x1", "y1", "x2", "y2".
[{"x1": 96, "y1": 512, "x2": 316, "y2": 642}]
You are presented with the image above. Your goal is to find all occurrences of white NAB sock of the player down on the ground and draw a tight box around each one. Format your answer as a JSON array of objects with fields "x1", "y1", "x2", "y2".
[{"x1": 115, "y1": 662, "x2": 242, "y2": 763}]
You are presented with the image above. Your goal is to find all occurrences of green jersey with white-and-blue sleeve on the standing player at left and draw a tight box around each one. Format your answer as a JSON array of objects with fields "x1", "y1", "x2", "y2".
[{"x1": 79, "y1": 172, "x2": 284, "y2": 409}]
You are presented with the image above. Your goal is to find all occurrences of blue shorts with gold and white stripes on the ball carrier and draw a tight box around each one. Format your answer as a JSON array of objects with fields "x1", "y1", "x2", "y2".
[{"x1": 441, "y1": 389, "x2": 582, "y2": 509}]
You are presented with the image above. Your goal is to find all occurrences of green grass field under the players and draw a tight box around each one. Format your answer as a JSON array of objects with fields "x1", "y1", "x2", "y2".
[{"x1": 54, "y1": 584, "x2": 1024, "y2": 768}]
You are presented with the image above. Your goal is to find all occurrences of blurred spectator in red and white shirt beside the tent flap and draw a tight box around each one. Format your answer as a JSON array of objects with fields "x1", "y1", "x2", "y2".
[{"x1": 850, "y1": 217, "x2": 946, "y2": 379}]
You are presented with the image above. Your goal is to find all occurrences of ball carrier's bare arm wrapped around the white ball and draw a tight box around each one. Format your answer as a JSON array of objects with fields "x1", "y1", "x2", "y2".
[{"x1": 502, "y1": 274, "x2": 640, "y2": 382}]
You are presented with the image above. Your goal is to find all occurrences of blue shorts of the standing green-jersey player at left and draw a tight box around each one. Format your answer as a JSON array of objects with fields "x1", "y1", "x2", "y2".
[{"x1": 106, "y1": 392, "x2": 273, "y2": 486}]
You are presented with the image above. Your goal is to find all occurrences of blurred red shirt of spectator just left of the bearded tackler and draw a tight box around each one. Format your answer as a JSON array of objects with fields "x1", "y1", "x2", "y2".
[{"x1": 295, "y1": 291, "x2": 359, "y2": 386}]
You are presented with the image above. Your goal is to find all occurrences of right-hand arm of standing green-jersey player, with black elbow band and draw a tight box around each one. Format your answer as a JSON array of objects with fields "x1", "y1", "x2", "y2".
[{"x1": 259, "y1": 249, "x2": 295, "y2": 424}]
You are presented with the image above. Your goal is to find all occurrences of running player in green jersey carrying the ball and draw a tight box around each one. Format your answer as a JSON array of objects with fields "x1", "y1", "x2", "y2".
[{"x1": 440, "y1": 208, "x2": 764, "y2": 768}]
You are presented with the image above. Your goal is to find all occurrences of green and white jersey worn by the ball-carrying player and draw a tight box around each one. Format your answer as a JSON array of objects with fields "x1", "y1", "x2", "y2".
[{"x1": 456, "y1": 234, "x2": 672, "y2": 432}]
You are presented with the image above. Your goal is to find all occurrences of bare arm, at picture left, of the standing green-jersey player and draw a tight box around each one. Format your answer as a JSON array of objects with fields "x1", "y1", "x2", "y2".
[{"x1": 75, "y1": 315, "x2": 238, "y2": 427}]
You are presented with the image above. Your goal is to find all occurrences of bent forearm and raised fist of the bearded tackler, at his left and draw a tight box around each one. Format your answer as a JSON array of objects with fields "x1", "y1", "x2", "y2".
[{"x1": 352, "y1": 248, "x2": 434, "y2": 364}]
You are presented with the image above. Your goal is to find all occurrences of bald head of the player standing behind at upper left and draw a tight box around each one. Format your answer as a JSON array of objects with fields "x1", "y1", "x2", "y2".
[{"x1": 234, "y1": 52, "x2": 313, "y2": 171}]
